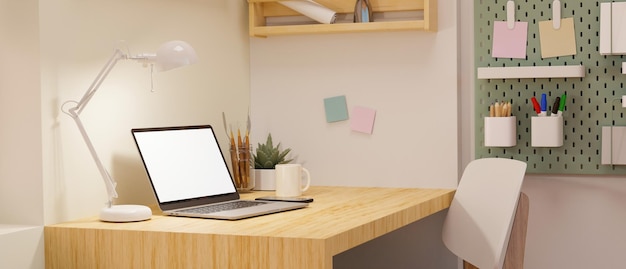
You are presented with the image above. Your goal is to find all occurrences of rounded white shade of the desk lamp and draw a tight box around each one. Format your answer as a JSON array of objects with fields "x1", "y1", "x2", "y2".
[{"x1": 155, "y1": 40, "x2": 198, "y2": 71}]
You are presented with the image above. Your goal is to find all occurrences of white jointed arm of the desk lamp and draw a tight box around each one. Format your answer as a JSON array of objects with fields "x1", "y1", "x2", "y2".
[{"x1": 63, "y1": 49, "x2": 128, "y2": 207}]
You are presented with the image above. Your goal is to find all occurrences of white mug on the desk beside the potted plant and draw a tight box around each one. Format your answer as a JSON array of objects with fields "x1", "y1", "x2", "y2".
[{"x1": 275, "y1": 164, "x2": 311, "y2": 197}]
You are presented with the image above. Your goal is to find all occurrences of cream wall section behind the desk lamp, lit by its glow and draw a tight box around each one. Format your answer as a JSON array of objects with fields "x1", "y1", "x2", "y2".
[{"x1": 39, "y1": 0, "x2": 249, "y2": 223}]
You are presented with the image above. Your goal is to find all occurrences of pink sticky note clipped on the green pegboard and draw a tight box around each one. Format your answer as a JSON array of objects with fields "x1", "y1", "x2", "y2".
[{"x1": 491, "y1": 21, "x2": 528, "y2": 59}]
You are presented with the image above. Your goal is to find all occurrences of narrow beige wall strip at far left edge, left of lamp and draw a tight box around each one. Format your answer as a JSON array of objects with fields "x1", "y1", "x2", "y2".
[{"x1": 0, "y1": 0, "x2": 43, "y2": 225}]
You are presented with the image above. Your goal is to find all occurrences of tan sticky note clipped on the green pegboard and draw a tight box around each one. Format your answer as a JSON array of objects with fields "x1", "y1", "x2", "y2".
[{"x1": 539, "y1": 18, "x2": 576, "y2": 58}]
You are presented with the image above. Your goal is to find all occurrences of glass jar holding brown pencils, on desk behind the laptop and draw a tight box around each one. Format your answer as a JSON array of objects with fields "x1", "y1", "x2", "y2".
[{"x1": 230, "y1": 146, "x2": 255, "y2": 192}]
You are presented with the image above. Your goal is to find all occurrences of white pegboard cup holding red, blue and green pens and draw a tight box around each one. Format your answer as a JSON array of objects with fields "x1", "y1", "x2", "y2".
[{"x1": 530, "y1": 117, "x2": 563, "y2": 147}]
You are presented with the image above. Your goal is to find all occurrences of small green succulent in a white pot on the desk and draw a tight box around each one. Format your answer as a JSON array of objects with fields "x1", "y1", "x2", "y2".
[{"x1": 253, "y1": 133, "x2": 293, "y2": 190}]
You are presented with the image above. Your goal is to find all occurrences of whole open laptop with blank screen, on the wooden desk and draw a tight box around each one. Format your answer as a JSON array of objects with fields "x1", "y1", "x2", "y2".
[{"x1": 131, "y1": 125, "x2": 308, "y2": 220}]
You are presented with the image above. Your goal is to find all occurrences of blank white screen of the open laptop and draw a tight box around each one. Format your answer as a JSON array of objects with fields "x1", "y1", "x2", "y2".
[{"x1": 133, "y1": 128, "x2": 236, "y2": 203}]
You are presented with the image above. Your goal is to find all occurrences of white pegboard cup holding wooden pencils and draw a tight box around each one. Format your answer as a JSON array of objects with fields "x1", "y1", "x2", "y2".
[{"x1": 485, "y1": 116, "x2": 517, "y2": 147}]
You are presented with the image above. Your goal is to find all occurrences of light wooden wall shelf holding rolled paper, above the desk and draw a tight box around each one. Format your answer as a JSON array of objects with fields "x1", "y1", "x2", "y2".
[{"x1": 248, "y1": 0, "x2": 437, "y2": 37}]
